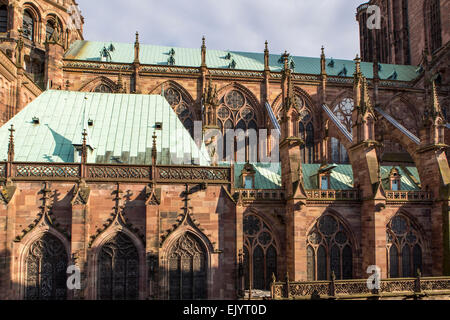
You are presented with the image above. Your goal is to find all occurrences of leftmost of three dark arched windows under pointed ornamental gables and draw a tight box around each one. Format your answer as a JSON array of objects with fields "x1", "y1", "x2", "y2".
[{"x1": 25, "y1": 233, "x2": 67, "y2": 300}]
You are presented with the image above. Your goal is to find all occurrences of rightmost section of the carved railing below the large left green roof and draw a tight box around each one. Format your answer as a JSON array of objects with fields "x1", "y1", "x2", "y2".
[{"x1": 155, "y1": 166, "x2": 231, "y2": 183}]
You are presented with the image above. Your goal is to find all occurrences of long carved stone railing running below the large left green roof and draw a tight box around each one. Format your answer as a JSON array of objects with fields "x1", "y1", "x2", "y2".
[{"x1": 0, "y1": 162, "x2": 232, "y2": 184}]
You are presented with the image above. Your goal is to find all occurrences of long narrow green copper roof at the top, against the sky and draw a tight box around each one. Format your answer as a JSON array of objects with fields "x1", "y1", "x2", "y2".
[{"x1": 65, "y1": 40, "x2": 419, "y2": 81}]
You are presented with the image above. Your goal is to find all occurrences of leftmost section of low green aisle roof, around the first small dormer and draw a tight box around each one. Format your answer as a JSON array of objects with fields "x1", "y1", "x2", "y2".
[{"x1": 234, "y1": 163, "x2": 281, "y2": 190}]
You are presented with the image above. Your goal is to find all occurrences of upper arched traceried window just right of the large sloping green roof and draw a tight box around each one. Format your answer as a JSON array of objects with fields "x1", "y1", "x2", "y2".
[{"x1": 217, "y1": 90, "x2": 258, "y2": 162}]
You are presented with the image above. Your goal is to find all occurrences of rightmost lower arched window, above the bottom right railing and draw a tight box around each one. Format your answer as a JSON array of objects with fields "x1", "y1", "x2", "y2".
[{"x1": 387, "y1": 214, "x2": 423, "y2": 278}]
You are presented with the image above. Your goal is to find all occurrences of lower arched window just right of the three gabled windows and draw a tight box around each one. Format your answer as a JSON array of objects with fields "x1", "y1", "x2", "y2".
[{"x1": 244, "y1": 214, "x2": 278, "y2": 290}]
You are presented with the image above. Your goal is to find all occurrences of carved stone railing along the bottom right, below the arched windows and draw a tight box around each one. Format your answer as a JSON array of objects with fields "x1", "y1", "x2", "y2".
[{"x1": 271, "y1": 276, "x2": 450, "y2": 300}]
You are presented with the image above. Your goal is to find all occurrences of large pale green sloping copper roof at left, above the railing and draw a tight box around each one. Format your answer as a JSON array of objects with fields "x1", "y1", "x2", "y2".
[{"x1": 0, "y1": 90, "x2": 210, "y2": 165}]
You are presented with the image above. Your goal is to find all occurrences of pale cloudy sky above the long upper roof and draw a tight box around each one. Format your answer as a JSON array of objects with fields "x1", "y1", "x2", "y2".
[{"x1": 78, "y1": 0, "x2": 365, "y2": 59}]
